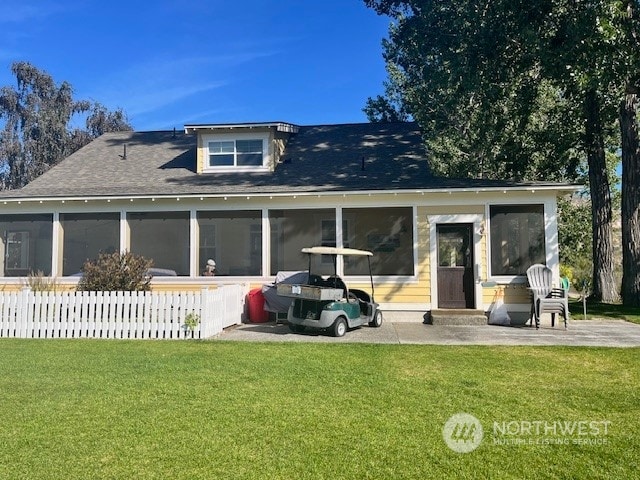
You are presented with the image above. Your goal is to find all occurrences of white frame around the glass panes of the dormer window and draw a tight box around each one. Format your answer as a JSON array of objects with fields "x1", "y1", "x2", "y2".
[{"x1": 202, "y1": 132, "x2": 270, "y2": 173}]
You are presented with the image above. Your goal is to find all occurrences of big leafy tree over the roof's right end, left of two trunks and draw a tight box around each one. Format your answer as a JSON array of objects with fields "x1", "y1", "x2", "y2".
[{"x1": 365, "y1": 0, "x2": 637, "y2": 301}]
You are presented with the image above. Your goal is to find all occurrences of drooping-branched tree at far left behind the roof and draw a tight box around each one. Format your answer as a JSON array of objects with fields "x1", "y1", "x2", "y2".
[{"x1": 0, "y1": 62, "x2": 132, "y2": 189}]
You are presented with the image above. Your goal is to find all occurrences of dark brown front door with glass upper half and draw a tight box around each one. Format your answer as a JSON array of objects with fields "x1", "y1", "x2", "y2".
[{"x1": 436, "y1": 223, "x2": 475, "y2": 308}]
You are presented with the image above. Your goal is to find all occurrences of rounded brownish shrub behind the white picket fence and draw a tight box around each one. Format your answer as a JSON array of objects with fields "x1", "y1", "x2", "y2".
[{"x1": 78, "y1": 252, "x2": 153, "y2": 292}]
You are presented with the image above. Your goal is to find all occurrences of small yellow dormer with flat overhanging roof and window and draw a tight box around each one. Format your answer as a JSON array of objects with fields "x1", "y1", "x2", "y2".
[{"x1": 184, "y1": 122, "x2": 298, "y2": 174}]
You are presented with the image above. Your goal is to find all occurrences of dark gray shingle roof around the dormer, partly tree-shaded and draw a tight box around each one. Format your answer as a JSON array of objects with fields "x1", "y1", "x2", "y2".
[{"x1": 2, "y1": 123, "x2": 564, "y2": 198}]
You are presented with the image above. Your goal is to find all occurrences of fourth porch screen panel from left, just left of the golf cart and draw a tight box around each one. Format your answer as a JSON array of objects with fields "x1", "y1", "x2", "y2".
[{"x1": 197, "y1": 210, "x2": 262, "y2": 276}]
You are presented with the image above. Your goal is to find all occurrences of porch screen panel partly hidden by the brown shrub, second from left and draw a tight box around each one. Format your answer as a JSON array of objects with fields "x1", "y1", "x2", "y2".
[{"x1": 60, "y1": 213, "x2": 120, "y2": 276}]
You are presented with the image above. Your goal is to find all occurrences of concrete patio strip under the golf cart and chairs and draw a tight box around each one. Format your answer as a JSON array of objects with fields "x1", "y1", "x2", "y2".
[{"x1": 215, "y1": 320, "x2": 640, "y2": 347}]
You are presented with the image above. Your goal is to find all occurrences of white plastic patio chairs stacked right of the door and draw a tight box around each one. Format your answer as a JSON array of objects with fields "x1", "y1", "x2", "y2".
[{"x1": 527, "y1": 263, "x2": 569, "y2": 328}]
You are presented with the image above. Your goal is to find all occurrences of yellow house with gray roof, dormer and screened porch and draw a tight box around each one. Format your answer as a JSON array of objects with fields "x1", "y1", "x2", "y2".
[{"x1": 0, "y1": 122, "x2": 574, "y2": 321}]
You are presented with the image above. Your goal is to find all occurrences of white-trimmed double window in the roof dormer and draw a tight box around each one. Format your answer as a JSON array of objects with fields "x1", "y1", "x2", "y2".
[{"x1": 204, "y1": 133, "x2": 269, "y2": 172}]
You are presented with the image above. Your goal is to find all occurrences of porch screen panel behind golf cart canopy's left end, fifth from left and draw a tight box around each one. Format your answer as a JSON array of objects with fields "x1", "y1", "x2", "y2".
[{"x1": 269, "y1": 208, "x2": 336, "y2": 275}]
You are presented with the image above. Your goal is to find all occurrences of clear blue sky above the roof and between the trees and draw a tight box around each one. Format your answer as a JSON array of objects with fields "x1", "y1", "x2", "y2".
[{"x1": 0, "y1": 0, "x2": 389, "y2": 130}]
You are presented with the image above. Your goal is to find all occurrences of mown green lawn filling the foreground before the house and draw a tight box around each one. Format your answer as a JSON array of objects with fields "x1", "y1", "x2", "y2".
[{"x1": 0, "y1": 339, "x2": 640, "y2": 480}]
